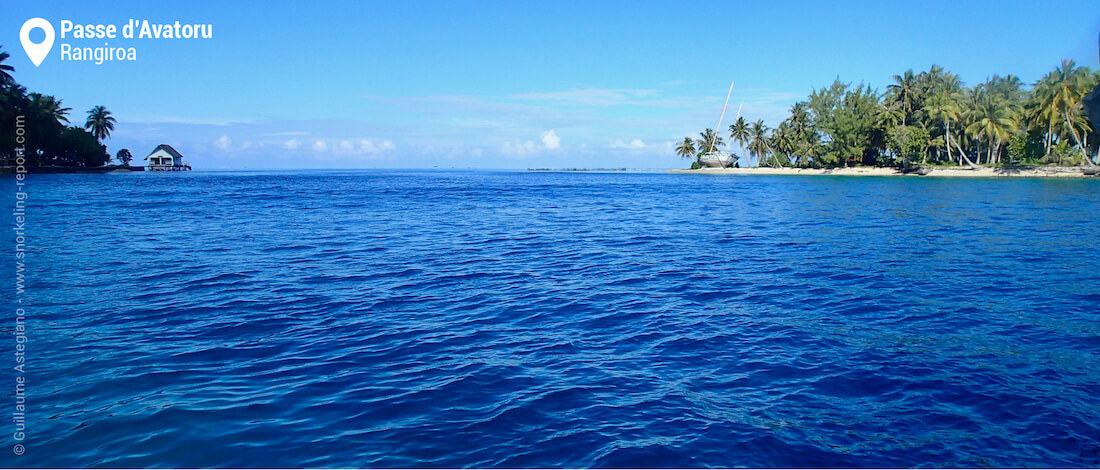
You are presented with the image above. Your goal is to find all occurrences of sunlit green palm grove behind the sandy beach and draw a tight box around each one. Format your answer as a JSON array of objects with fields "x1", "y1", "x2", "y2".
[{"x1": 675, "y1": 61, "x2": 1100, "y2": 167}]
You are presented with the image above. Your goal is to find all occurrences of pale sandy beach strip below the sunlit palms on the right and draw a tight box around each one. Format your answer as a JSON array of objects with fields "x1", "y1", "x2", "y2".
[{"x1": 669, "y1": 166, "x2": 1100, "y2": 179}]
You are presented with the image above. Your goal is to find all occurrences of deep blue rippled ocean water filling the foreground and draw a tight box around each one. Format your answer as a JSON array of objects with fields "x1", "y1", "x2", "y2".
[{"x1": 0, "y1": 171, "x2": 1100, "y2": 468}]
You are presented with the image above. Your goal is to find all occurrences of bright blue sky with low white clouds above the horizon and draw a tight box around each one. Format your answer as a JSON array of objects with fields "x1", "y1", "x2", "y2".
[{"x1": 0, "y1": 0, "x2": 1100, "y2": 170}]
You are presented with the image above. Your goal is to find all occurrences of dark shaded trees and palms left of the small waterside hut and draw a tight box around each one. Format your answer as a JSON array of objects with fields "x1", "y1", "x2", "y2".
[{"x1": 0, "y1": 45, "x2": 114, "y2": 166}]
